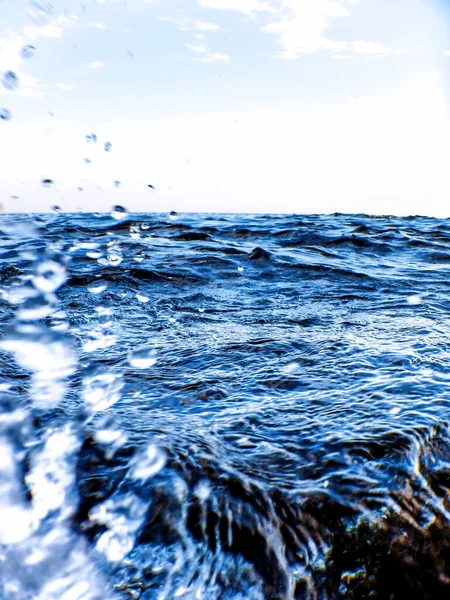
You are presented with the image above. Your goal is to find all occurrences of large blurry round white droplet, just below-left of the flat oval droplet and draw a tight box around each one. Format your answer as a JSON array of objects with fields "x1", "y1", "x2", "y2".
[{"x1": 82, "y1": 370, "x2": 123, "y2": 412}]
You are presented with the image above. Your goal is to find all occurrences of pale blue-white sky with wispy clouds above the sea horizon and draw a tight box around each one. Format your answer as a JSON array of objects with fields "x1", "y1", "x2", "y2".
[{"x1": 0, "y1": 0, "x2": 450, "y2": 216}]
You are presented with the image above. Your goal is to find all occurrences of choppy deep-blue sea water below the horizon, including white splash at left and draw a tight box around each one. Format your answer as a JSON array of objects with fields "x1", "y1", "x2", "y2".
[{"x1": 0, "y1": 210, "x2": 450, "y2": 600}]
